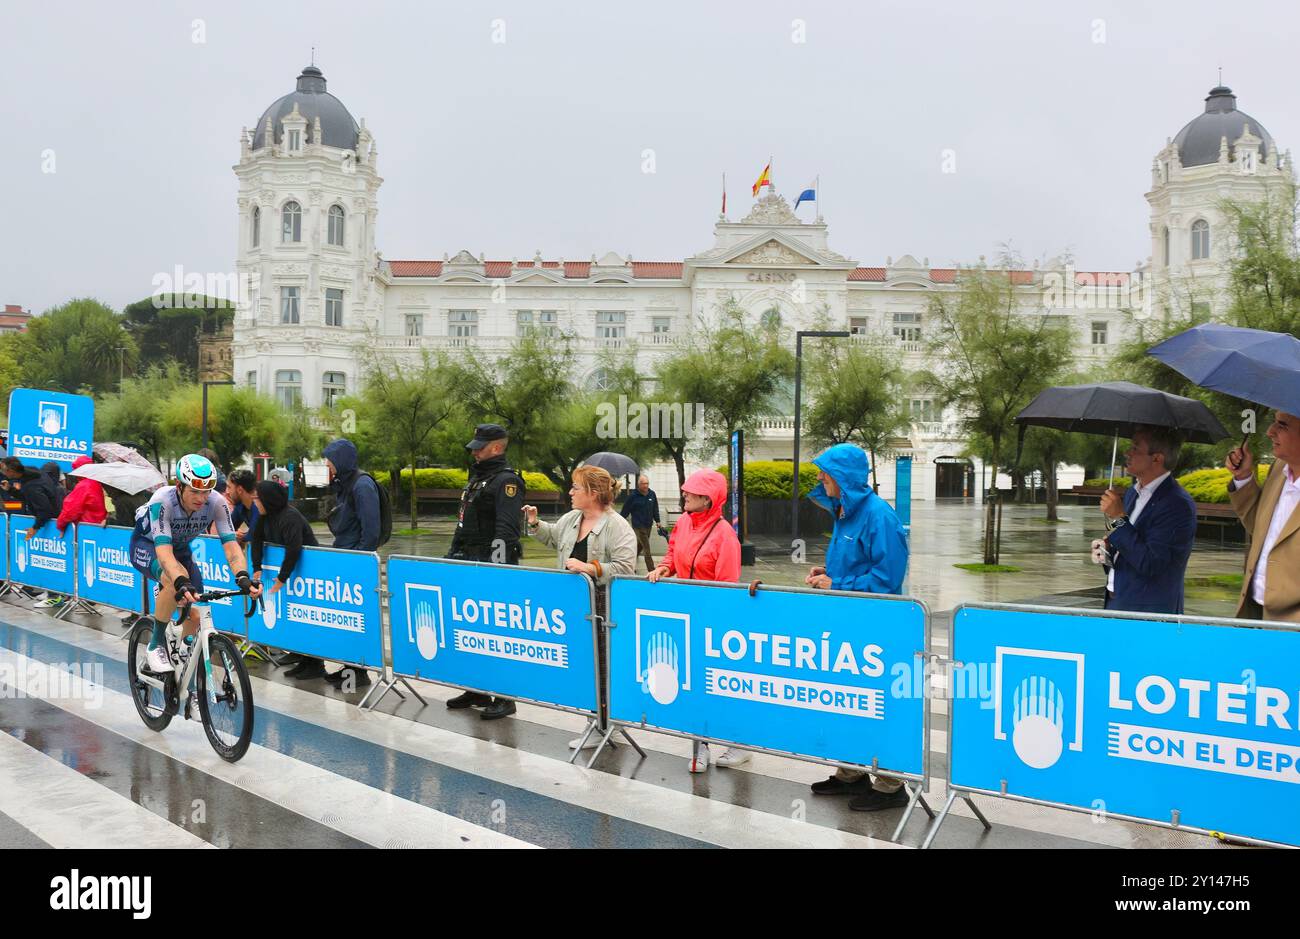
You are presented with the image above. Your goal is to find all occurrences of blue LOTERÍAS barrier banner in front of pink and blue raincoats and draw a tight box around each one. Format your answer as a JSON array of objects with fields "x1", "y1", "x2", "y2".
[{"x1": 610, "y1": 577, "x2": 928, "y2": 778}]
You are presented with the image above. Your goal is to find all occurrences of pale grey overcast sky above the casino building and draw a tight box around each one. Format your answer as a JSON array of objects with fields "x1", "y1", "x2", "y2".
[{"x1": 0, "y1": 0, "x2": 1300, "y2": 312}]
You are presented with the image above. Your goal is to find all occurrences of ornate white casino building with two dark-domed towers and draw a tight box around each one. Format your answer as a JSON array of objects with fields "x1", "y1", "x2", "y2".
[{"x1": 234, "y1": 66, "x2": 1292, "y2": 498}]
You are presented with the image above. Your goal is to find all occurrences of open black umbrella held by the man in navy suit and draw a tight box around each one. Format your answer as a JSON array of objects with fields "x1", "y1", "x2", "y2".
[{"x1": 1015, "y1": 381, "x2": 1229, "y2": 485}]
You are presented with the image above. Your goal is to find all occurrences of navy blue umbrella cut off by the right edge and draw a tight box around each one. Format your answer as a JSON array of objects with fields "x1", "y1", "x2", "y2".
[{"x1": 1147, "y1": 323, "x2": 1300, "y2": 415}]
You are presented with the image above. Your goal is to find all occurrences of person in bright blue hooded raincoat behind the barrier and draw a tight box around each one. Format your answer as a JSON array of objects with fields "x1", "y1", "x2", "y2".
[{"x1": 805, "y1": 443, "x2": 907, "y2": 812}]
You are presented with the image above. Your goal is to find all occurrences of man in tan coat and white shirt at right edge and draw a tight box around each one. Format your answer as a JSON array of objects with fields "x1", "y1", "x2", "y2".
[{"x1": 1227, "y1": 411, "x2": 1300, "y2": 622}]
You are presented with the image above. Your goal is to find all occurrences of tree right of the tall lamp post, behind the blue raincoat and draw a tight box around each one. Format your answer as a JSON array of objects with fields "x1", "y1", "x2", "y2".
[{"x1": 803, "y1": 329, "x2": 910, "y2": 485}]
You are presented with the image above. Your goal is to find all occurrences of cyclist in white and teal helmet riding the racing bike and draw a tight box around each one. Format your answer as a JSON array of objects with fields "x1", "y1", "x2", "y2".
[{"x1": 130, "y1": 454, "x2": 261, "y2": 674}]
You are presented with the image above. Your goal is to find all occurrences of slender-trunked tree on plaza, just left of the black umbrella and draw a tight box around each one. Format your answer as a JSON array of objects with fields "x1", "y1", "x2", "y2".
[{"x1": 927, "y1": 258, "x2": 1073, "y2": 564}]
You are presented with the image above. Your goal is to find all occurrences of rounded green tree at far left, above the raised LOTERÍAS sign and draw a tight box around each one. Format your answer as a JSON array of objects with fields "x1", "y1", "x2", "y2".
[{"x1": 14, "y1": 298, "x2": 137, "y2": 394}]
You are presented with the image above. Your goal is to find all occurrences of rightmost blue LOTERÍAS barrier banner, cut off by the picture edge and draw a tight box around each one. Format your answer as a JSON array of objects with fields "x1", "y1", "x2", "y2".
[{"x1": 949, "y1": 606, "x2": 1300, "y2": 845}]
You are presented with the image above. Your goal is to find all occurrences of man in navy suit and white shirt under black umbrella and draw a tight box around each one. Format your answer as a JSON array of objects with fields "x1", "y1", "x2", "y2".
[{"x1": 1093, "y1": 427, "x2": 1196, "y2": 613}]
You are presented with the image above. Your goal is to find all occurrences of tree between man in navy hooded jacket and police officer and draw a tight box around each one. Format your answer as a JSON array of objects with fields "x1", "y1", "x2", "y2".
[{"x1": 361, "y1": 352, "x2": 458, "y2": 528}]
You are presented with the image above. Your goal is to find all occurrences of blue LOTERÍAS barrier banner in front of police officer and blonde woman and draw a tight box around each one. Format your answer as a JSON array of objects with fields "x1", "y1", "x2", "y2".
[{"x1": 389, "y1": 557, "x2": 597, "y2": 714}]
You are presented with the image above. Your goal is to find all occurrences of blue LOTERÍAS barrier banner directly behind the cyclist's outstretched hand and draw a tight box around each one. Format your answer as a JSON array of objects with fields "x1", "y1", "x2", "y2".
[{"x1": 248, "y1": 545, "x2": 384, "y2": 668}]
